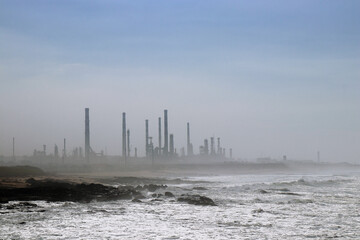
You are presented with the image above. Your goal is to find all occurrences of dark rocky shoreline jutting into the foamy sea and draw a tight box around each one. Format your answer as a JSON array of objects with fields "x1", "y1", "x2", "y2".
[{"x1": 0, "y1": 178, "x2": 216, "y2": 206}]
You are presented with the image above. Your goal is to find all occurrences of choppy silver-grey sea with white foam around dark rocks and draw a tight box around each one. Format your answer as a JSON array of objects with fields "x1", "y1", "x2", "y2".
[{"x1": 0, "y1": 174, "x2": 360, "y2": 240}]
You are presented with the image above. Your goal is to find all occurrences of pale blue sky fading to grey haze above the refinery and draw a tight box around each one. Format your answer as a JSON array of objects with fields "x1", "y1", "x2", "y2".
[{"x1": 0, "y1": 0, "x2": 360, "y2": 163}]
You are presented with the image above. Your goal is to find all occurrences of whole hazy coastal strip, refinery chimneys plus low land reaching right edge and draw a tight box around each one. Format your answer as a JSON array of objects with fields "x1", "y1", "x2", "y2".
[{"x1": 0, "y1": 108, "x2": 358, "y2": 174}]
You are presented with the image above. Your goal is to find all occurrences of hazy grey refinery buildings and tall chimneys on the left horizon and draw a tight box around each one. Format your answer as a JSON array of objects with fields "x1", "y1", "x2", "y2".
[{"x1": 0, "y1": 108, "x2": 233, "y2": 166}]
